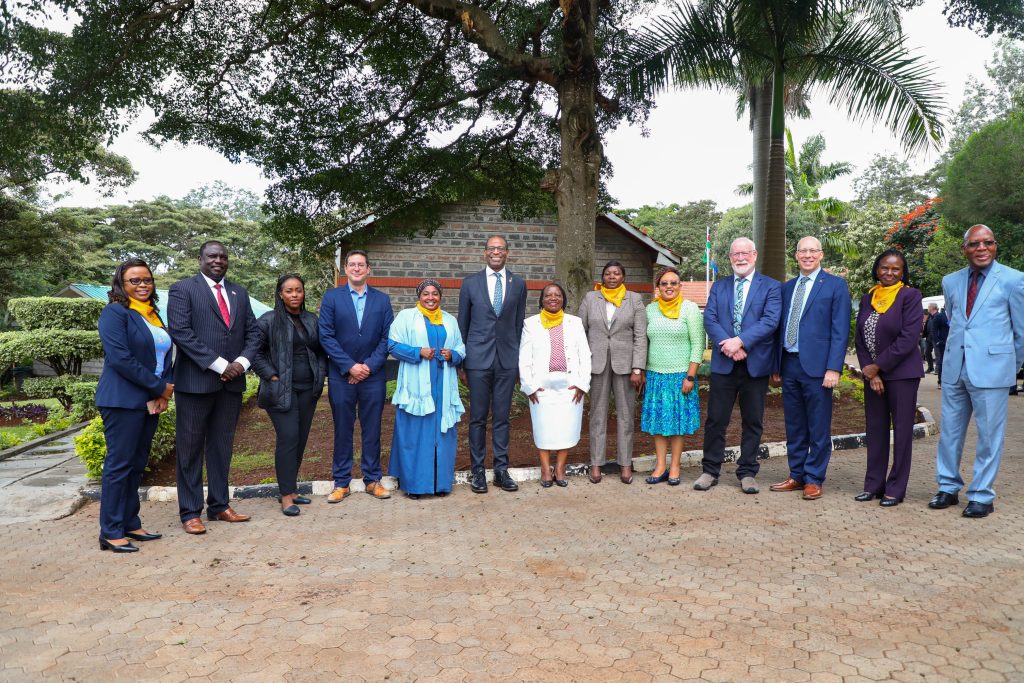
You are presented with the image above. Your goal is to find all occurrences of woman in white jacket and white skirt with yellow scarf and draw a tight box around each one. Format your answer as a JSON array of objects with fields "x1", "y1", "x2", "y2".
[{"x1": 519, "y1": 283, "x2": 590, "y2": 488}]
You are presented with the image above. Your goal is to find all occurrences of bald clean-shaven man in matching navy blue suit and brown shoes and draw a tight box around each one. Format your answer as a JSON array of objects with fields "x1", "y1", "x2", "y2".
[{"x1": 771, "y1": 237, "x2": 853, "y2": 501}]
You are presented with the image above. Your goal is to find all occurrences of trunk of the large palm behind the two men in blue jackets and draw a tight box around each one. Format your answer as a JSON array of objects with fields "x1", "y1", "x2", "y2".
[{"x1": 760, "y1": 65, "x2": 785, "y2": 282}]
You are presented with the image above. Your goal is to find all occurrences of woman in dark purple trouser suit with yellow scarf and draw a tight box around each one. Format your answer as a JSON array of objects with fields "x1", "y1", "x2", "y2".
[{"x1": 854, "y1": 249, "x2": 925, "y2": 508}]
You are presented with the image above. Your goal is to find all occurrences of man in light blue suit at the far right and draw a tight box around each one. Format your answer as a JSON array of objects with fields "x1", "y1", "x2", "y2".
[{"x1": 928, "y1": 225, "x2": 1024, "y2": 517}]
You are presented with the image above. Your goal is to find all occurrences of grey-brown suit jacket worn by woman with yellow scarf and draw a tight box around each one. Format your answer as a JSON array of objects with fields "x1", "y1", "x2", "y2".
[{"x1": 580, "y1": 291, "x2": 647, "y2": 375}]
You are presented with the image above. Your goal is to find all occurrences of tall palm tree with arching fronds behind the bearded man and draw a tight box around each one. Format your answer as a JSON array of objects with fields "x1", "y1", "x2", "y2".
[{"x1": 632, "y1": 0, "x2": 943, "y2": 280}]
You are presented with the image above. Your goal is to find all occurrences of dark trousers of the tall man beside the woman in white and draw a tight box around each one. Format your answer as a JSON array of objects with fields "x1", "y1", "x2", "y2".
[{"x1": 466, "y1": 367, "x2": 519, "y2": 474}]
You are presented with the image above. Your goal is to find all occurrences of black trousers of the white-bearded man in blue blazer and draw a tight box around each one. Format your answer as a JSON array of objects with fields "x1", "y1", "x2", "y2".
[{"x1": 700, "y1": 361, "x2": 768, "y2": 479}]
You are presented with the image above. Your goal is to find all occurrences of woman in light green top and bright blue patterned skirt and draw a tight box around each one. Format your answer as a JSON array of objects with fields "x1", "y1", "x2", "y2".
[{"x1": 640, "y1": 267, "x2": 705, "y2": 486}]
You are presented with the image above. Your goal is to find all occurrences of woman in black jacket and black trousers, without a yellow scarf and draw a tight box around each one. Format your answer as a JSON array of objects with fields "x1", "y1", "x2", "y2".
[{"x1": 252, "y1": 273, "x2": 327, "y2": 517}]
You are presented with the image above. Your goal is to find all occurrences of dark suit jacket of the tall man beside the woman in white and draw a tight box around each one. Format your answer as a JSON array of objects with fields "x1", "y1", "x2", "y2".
[{"x1": 459, "y1": 268, "x2": 526, "y2": 370}]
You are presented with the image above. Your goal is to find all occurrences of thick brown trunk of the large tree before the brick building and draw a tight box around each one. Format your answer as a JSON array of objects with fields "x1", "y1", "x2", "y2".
[{"x1": 555, "y1": 0, "x2": 603, "y2": 312}]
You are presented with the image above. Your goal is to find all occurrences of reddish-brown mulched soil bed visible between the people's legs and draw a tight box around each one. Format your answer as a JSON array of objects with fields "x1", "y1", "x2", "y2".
[{"x1": 143, "y1": 391, "x2": 864, "y2": 485}]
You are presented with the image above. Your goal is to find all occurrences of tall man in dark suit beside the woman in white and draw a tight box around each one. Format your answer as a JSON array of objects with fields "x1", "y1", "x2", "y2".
[{"x1": 459, "y1": 234, "x2": 526, "y2": 494}]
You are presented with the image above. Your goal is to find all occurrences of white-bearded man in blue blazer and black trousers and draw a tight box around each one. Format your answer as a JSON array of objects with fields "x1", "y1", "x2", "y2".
[{"x1": 693, "y1": 238, "x2": 782, "y2": 494}]
